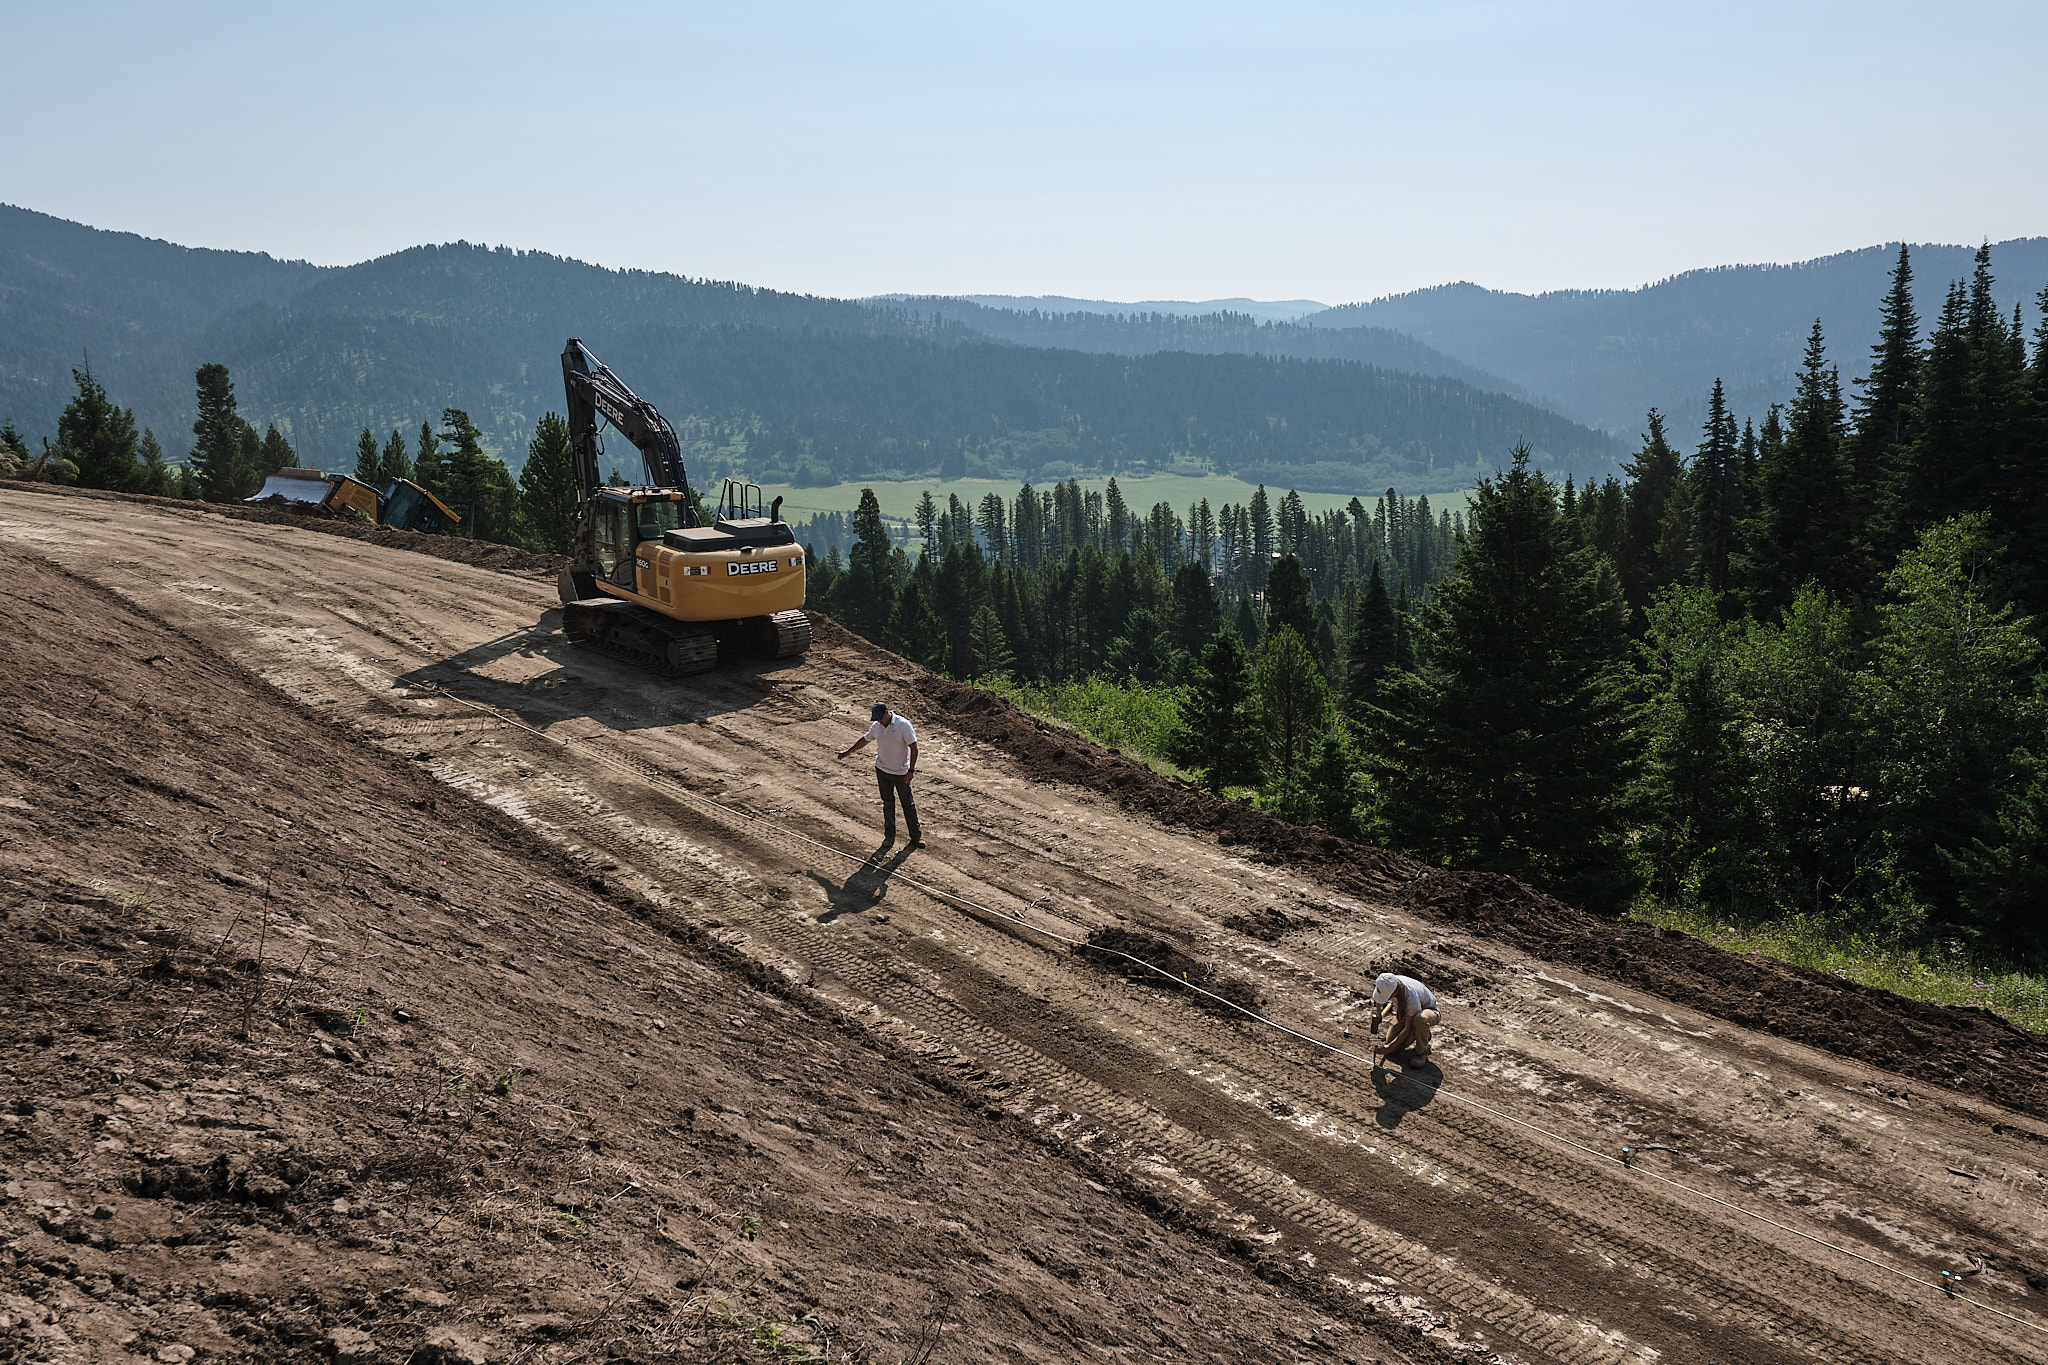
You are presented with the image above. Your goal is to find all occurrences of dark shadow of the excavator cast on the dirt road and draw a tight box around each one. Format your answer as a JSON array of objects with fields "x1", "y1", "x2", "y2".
[{"x1": 397, "y1": 608, "x2": 836, "y2": 731}]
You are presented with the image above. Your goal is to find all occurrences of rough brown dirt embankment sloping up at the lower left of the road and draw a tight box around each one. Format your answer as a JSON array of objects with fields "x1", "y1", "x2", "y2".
[{"x1": 0, "y1": 557, "x2": 1448, "y2": 1361}]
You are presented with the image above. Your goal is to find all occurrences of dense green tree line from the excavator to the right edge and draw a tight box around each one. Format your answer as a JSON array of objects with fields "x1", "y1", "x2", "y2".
[{"x1": 815, "y1": 240, "x2": 2048, "y2": 956}]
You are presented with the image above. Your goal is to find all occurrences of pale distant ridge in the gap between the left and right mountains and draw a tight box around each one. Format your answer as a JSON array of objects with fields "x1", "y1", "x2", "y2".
[{"x1": 883, "y1": 297, "x2": 1536, "y2": 401}]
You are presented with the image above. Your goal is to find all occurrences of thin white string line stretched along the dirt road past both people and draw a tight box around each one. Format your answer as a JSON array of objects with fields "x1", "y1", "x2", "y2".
[{"x1": 375, "y1": 654, "x2": 2048, "y2": 1334}]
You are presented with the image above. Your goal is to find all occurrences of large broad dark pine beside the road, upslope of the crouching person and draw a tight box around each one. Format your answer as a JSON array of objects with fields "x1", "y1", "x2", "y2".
[{"x1": 1374, "y1": 446, "x2": 1636, "y2": 913}]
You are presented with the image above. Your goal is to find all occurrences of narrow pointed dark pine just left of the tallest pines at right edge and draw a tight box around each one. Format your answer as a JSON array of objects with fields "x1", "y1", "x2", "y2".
[{"x1": 1739, "y1": 319, "x2": 1860, "y2": 618}]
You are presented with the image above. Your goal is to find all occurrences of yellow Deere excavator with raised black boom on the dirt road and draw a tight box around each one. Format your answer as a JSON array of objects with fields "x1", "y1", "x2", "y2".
[{"x1": 557, "y1": 336, "x2": 811, "y2": 675}]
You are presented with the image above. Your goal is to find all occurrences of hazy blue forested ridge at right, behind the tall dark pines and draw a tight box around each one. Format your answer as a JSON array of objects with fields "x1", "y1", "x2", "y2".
[{"x1": 1303, "y1": 237, "x2": 2048, "y2": 438}]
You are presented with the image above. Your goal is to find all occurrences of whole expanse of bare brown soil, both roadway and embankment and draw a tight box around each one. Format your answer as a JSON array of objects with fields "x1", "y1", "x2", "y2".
[{"x1": 0, "y1": 487, "x2": 2048, "y2": 1363}]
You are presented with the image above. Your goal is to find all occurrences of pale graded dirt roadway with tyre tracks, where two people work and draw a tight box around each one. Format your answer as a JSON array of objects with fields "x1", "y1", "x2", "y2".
[{"x1": 0, "y1": 491, "x2": 2048, "y2": 1361}]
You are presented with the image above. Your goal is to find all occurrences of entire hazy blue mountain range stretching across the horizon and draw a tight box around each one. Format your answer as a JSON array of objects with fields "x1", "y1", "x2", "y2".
[{"x1": 16, "y1": 207, "x2": 2048, "y2": 491}]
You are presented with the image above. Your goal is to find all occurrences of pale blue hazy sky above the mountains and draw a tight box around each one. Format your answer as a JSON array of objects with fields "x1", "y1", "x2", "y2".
[{"x1": 0, "y1": 0, "x2": 2048, "y2": 303}]
